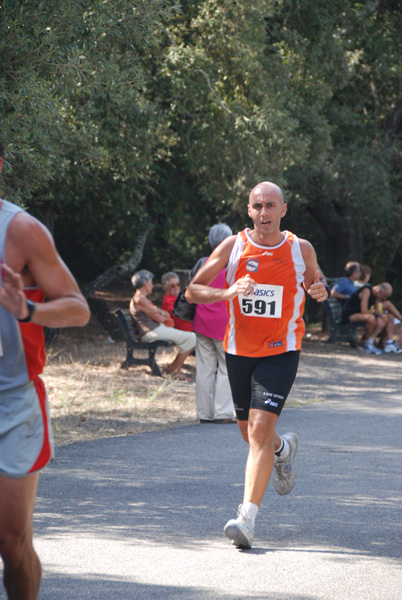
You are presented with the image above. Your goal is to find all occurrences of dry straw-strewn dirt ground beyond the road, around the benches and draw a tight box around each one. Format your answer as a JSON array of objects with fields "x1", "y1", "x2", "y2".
[{"x1": 43, "y1": 284, "x2": 402, "y2": 446}]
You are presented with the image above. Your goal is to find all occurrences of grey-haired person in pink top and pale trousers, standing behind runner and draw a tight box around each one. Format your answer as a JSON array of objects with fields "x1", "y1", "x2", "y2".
[{"x1": 193, "y1": 223, "x2": 236, "y2": 423}]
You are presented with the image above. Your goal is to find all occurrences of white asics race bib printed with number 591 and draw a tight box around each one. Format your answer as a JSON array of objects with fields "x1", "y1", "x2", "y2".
[{"x1": 239, "y1": 283, "x2": 283, "y2": 319}]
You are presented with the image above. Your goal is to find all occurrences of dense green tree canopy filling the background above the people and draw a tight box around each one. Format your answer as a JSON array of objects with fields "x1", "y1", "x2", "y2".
[{"x1": 0, "y1": 0, "x2": 402, "y2": 294}]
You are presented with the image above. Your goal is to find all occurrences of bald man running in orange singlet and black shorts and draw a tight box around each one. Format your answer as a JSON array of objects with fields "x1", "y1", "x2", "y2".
[{"x1": 186, "y1": 181, "x2": 328, "y2": 548}]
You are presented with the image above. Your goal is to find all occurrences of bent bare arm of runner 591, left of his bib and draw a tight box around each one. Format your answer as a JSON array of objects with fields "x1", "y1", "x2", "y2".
[{"x1": 186, "y1": 235, "x2": 255, "y2": 304}]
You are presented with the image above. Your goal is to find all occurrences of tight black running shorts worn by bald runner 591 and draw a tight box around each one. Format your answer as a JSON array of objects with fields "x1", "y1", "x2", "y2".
[{"x1": 226, "y1": 350, "x2": 300, "y2": 421}]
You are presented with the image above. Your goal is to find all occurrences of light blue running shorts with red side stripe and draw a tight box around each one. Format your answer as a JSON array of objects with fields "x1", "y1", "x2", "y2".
[{"x1": 0, "y1": 377, "x2": 53, "y2": 477}]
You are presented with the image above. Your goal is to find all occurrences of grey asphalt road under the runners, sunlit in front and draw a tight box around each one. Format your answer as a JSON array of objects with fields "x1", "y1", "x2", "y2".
[{"x1": 3, "y1": 354, "x2": 402, "y2": 600}]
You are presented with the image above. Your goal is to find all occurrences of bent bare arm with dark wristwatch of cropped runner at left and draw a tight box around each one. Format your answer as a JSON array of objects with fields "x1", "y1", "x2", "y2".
[{"x1": 0, "y1": 213, "x2": 91, "y2": 327}]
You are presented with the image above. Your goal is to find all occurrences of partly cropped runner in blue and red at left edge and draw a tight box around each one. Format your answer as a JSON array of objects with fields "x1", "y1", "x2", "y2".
[{"x1": 0, "y1": 142, "x2": 90, "y2": 600}]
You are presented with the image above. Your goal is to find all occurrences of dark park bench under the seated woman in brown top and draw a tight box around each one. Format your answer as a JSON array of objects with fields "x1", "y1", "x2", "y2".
[{"x1": 115, "y1": 308, "x2": 173, "y2": 377}]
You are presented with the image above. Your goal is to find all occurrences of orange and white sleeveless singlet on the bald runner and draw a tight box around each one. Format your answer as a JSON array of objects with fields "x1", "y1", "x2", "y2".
[{"x1": 223, "y1": 228, "x2": 306, "y2": 357}]
